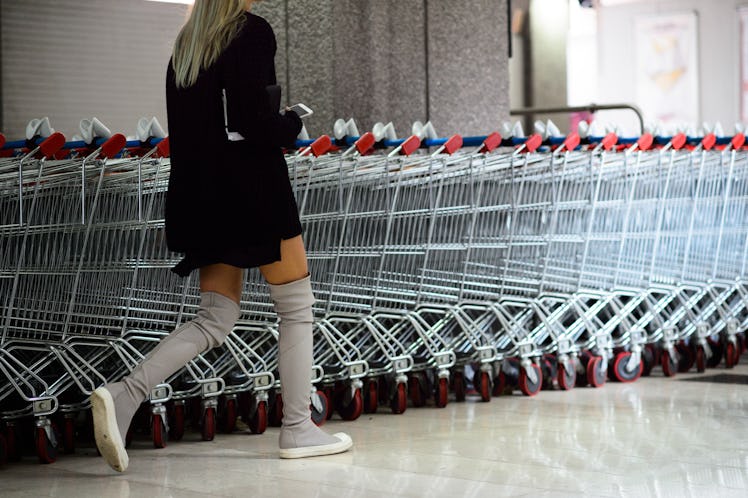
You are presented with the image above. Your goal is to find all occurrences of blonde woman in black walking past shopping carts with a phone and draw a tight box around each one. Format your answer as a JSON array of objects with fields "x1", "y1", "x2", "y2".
[{"x1": 91, "y1": 0, "x2": 352, "y2": 472}]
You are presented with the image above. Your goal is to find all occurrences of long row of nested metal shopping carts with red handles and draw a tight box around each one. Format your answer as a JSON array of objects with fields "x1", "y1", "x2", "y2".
[{"x1": 0, "y1": 117, "x2": 748, "y2": 463}]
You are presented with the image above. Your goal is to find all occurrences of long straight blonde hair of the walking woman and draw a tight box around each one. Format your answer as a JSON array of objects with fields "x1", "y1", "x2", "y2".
[{"x1": 172, "y1": 0, "x2": 247, "y2": 88}]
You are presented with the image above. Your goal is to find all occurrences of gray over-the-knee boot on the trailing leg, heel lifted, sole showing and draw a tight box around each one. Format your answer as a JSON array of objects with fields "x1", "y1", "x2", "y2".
[{"x1": 91, "y1": 292, "x2": 240, "y2": 472}]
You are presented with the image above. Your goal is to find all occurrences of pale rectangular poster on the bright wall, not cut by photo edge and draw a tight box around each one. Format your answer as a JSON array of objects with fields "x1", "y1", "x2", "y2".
[{"x1": 634, "y1": 12, "x2": 699, "y2": 126}]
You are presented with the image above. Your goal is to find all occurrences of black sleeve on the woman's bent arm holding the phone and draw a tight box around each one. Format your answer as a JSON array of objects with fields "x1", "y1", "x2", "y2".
[{"x1": 222, "y1": 25, "x2": 302, "y2": 147}]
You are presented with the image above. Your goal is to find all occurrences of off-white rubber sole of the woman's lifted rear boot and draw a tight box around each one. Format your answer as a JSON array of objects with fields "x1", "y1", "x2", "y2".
[{"x1": 91, "y1": 387, "x2": 130, "y2": 472}]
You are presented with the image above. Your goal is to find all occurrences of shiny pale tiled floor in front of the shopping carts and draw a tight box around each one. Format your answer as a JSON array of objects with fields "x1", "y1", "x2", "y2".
[{"x1": 0, "y1": 356, "x2": 748, "y2": 498}]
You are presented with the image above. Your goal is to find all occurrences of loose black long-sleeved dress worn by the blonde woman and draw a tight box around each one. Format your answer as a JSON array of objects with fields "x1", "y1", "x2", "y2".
[{"x1": 166, "y1": 13, "x2": 301, "y2": 276}]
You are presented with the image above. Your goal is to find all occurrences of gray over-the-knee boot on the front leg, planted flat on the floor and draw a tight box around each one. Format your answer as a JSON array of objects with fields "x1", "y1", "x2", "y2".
[{"x1": 269, "y1": 277, "x2": 353, "y2": 458}]
